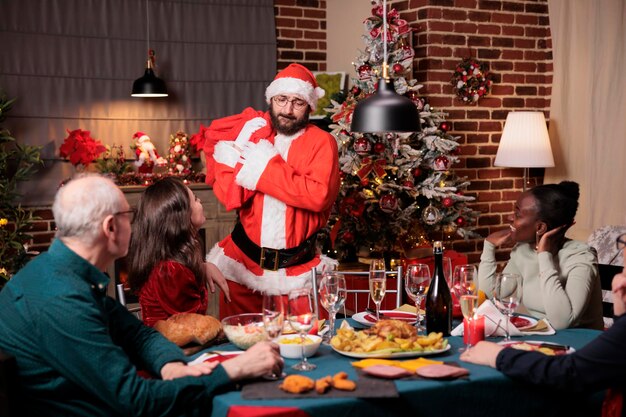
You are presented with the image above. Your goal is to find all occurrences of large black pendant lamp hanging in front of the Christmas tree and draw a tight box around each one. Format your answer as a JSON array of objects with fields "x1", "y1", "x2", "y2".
[{"x1": 350, "y1": 0, "x2": 421, "y2": 133}]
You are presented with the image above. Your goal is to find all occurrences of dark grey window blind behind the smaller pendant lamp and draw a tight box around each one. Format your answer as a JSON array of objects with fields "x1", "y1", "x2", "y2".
[{"x1": 0, "y1": 0, "x2": 276, "y2": 205}]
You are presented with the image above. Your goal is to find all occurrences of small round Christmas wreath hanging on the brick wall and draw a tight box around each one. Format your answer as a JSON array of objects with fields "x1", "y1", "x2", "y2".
[{"x1": 451, "y1": 58, "x2": 493, "y2": 104}]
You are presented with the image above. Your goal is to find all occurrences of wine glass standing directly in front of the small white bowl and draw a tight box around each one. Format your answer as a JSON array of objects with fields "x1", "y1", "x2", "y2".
[{"x1": 288, "y1": 288, "x2": 317, "y2": 371}]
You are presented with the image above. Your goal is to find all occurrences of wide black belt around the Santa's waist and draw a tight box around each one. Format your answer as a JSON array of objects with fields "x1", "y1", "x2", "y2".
[{"x1": 230, "y1": 223, "x2": 317, "y2": 271}]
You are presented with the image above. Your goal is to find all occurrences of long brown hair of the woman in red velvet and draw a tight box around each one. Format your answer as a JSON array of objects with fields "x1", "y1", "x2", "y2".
[{"x1": 128, "y1": 177, "x2": 205, "y2": 292}]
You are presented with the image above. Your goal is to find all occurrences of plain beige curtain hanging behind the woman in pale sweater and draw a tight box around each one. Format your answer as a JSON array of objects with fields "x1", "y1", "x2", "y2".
[{"x1": 545, "y1": 0, "x2": 626, "y2": 241}]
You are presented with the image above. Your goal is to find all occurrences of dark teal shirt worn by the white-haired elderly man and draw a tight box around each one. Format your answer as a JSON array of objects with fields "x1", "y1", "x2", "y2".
[{"x1": 0, "y1": 240, "x2": 230, "y2": 416}]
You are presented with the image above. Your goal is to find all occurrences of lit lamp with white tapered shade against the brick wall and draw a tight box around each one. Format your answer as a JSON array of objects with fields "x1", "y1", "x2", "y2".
[{"x1": 493, "y1": 111, "x2": 554, "y2": 191}]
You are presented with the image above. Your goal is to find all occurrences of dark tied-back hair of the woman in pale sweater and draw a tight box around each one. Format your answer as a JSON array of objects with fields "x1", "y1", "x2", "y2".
[{"x1": 530, "y1": 181, "x2": 580, "y2": 230}]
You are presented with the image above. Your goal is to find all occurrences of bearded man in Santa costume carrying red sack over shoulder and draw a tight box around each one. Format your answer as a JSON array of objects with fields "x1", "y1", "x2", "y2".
[{"x1": 204, "y1": 64, "x2": 339, "y2": 317}]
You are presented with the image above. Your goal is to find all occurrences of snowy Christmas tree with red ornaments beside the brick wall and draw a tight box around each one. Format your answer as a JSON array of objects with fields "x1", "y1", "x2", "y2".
[{"x1": 324, "y1": 1, "x2": 478, "y2": 259}]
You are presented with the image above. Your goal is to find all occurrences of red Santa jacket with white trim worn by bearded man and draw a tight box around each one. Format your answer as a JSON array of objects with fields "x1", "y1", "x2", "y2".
[{"x1": 207, "y1": 115, "x2": 339, "y2": 294}]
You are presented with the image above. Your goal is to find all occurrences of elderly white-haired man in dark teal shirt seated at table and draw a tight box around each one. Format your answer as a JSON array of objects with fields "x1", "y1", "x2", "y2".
[{"x1": 0, "y1": 176, "x2": 283, "y2": 416}]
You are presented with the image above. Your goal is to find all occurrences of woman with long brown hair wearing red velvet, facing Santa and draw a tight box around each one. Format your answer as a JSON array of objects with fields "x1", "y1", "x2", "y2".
[{"x1": 128, "y1": 177, "x2": 208, "y2": 326}]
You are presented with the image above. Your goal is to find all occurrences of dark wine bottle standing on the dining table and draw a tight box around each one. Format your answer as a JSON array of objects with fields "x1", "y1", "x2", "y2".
[{"x1": 425, "y1": 241, "x2": 452, "y2": 336}]
